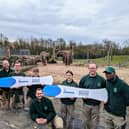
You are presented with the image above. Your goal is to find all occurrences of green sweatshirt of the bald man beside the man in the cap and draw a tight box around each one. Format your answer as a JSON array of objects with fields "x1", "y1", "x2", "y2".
[{"x1": 79, "y1": 74, "x2": 106, "y2": 105}]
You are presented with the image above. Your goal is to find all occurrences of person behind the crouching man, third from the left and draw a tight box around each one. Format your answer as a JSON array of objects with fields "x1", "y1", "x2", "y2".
[{"x1": 27, "y1": 68, "x2": 43, "y2": 107}]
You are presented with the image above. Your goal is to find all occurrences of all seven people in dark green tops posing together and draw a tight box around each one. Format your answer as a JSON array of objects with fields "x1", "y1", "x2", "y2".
[{"x1": 0, "y1": 60, "x2": 129, "y2": 129}]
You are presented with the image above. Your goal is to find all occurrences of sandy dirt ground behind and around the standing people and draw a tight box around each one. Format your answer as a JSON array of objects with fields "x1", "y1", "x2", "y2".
[{"x1": 0, "y1": 63, "x2": 129, "y2": 129}]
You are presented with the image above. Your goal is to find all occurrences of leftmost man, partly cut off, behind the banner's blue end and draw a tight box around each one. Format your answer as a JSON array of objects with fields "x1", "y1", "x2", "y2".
[{"x1": 0, "y1": 59, "x2": 14, "y2": 109}]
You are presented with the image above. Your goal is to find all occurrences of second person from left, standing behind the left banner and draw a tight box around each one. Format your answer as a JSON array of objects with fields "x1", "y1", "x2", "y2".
[{"x1": 9, "y1": 61, "x2": 25, "y2": 109}]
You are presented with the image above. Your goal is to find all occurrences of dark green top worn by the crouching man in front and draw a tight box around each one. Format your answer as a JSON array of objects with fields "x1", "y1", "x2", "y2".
[{"x1": 30, "y1": 97, "x2": 56, "y2": 123}]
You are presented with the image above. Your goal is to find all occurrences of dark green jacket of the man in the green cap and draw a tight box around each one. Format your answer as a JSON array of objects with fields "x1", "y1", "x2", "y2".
[{"x1": 105, "y1": 77, "x2": 129, "y2": 117}]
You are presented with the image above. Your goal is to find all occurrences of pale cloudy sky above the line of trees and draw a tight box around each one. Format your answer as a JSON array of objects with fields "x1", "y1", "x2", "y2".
[{"x1": 0, "y1": 0, "x2": 129, "y2": 44}]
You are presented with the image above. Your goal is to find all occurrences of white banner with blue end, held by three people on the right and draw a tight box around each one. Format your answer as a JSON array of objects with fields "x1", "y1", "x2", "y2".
[{"x1": 43, "y1": 85, "x2": 108, "y2": 102}]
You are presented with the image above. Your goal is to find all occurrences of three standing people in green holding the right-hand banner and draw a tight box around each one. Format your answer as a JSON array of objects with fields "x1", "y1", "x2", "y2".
[{"x1": 61, "y1": 63, "x2": 129, "y2": 129}]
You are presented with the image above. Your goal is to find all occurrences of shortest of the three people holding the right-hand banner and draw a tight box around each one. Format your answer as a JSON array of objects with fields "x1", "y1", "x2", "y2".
[{"x1": 60, "y1": 70, "x2": 78, "y2": 129}]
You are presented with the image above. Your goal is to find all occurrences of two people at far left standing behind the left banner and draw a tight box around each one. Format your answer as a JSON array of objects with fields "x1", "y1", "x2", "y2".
[{"x1": 0, "y1": 59, "x2": 25, "y2": 109}]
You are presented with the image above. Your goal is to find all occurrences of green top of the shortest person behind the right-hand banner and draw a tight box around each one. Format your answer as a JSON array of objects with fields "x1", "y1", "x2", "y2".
[{"x1": 60, "y1": 80, "x2": 78, "y2": 105}]
